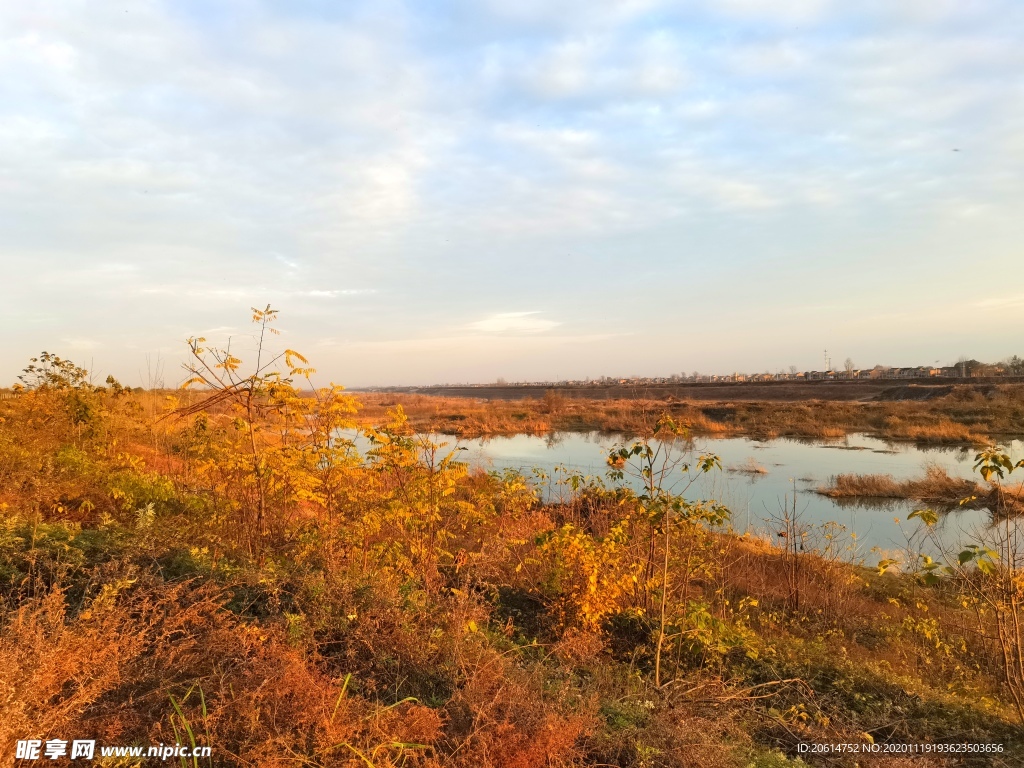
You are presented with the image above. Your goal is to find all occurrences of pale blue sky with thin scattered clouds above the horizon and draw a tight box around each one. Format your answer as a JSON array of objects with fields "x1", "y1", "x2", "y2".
[{"x1": 0, "y1": 0, "x2": 1024, "y2": 387}]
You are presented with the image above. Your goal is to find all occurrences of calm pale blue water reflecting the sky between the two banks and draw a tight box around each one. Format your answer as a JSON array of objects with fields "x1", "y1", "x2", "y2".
[{"x1": 437, "y1": 433, "x2": 1024, "y2": 565}]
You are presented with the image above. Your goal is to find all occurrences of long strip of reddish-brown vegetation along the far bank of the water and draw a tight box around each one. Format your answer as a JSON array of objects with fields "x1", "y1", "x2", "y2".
[{"x1": 358, "y1": 384, "x2": 1024, "y2": 445}]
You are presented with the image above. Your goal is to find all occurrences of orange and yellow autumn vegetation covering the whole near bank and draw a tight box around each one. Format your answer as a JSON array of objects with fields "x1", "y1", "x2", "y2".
[{"x1": 0, "y1": 333, "x2": 1024, "y2": 768}]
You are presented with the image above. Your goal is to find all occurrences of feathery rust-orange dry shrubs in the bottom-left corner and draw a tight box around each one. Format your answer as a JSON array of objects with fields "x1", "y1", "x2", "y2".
[{"x1": 0, "y1": 573, "x2": 452, "y2": 766}]
